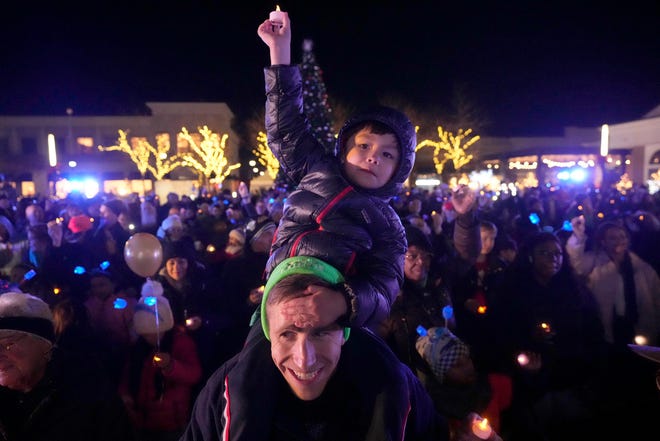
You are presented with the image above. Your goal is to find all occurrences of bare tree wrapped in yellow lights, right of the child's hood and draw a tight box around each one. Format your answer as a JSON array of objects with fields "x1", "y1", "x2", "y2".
[{"x1": 415, "y1": 126, "x2": 481, "y2": 174}]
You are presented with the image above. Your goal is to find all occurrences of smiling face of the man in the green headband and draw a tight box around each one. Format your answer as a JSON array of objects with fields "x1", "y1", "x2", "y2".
[{"x1": 267, "y1": 301, "x2": 345, "y2": 400}]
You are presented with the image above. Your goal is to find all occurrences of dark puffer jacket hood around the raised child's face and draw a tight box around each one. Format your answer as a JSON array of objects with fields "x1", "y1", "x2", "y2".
[{"x1": 335, "y1": 106, "x2": 417, "y2": 198}]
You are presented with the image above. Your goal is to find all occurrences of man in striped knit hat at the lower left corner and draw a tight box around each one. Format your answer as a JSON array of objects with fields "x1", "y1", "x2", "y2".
[{"x1": 0, "y1": 292, "x2": 135, "y2": 441}]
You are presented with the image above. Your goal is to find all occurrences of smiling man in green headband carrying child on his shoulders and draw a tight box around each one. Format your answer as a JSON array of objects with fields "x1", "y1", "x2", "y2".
[{"x1": 181, "y1": 256, "x2": 448, "y2": 441}]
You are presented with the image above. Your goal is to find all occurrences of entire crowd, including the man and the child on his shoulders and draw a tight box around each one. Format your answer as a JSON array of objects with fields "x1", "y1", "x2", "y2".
[{"x1": 0, "y1": 8, "x2": 660, "y2": 441}]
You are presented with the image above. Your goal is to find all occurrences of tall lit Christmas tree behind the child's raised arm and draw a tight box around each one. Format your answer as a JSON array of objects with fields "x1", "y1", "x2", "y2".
[{"x1": 300, "y1": 40, "x2": 335, "y2": 152}]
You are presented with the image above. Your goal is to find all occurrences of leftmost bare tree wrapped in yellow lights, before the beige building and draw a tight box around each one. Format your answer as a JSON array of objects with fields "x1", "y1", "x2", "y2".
[{"x1": 98, "y1": 130, "x2": 182, "y2": 180}]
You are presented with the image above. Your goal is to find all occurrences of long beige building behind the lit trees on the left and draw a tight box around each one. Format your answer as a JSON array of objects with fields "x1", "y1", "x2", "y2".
[{"x1": 0, "y1": 102, "x2": 240, "y2": 195}]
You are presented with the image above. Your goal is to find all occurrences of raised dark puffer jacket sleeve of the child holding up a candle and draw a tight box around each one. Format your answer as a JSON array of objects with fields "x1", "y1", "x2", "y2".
[{"x1": 264, "y1": 65, "x2": 325, "y2": 184}]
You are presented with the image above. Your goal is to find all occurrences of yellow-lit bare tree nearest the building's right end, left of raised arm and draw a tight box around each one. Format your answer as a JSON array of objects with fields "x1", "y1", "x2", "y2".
[{"x1": 179, "y1": 126, "x2": 241, "y2": 185}]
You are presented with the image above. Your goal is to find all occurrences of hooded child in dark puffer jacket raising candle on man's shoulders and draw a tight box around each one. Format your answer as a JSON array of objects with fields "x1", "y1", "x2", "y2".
[{"x1": 258, "y1": 12, "x2": 474, "y2": 328}]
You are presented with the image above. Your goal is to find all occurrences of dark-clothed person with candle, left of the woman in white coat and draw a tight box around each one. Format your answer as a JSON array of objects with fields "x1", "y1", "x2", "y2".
[{"x1": 481, "y1": 232, "x2": 605, "y2": 441}]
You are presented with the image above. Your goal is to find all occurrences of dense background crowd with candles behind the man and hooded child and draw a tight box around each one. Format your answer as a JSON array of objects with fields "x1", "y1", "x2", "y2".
[{"x1": 0, "y1": 171, "x2": 660, "y2": 440}]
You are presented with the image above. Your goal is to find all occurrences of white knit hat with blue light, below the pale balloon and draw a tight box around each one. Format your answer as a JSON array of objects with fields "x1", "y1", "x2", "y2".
[{"x1": 133, "y1": 280, "x2": 174, "y2": 334}]
